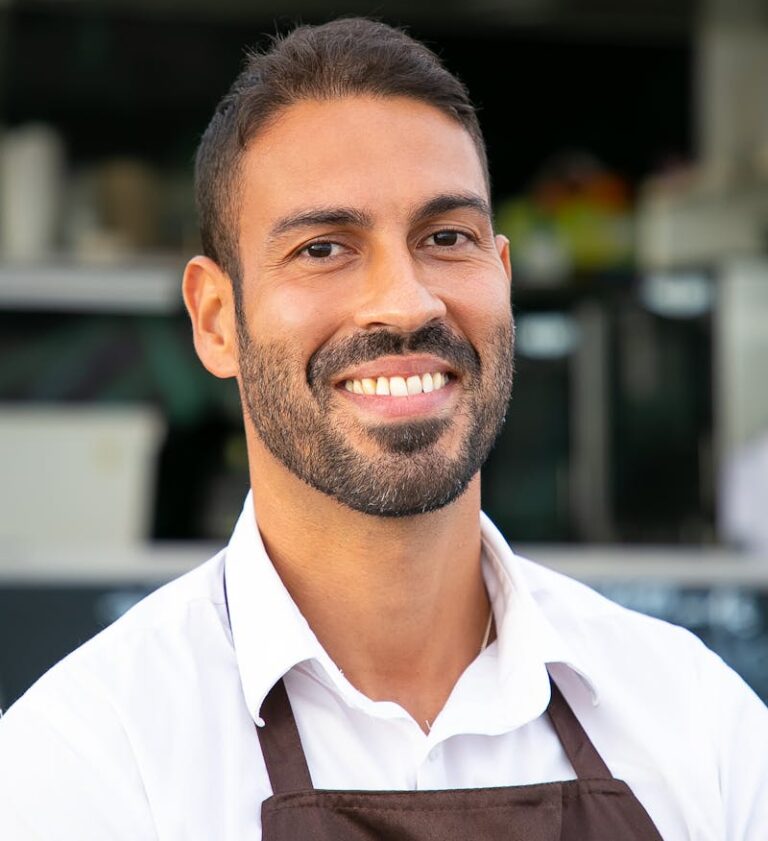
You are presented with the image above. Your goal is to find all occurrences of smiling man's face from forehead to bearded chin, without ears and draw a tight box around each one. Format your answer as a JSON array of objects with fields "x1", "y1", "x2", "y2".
[{"x1": 238, "y1": 97, "x2": 513, "y2": 516}]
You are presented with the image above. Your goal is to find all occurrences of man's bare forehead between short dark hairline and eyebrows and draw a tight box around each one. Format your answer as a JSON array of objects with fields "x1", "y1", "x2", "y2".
[{"x1": 240, "y1": 96, "x2": 487, "y2": 240}]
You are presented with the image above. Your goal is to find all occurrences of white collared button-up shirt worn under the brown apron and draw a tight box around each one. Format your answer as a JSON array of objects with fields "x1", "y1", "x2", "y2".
[{"x1": 0, "y1": 496, "x2": 768, "y2": 841}]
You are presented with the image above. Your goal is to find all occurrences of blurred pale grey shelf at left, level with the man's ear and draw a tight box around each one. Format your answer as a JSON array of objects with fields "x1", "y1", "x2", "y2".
[{"x1": 0, "y1": 259, "x2": 182, "y2": 315}]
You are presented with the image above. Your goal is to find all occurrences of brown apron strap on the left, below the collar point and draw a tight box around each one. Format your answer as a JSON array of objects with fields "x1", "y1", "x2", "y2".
[{"x1": 256, "y1": 678, "x2": 313, "y2": 794}]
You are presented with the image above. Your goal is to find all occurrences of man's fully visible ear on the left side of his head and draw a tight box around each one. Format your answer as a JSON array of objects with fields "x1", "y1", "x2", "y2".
[{"x1": 182, "y1": 257, "x2": 238, "y2": 378}]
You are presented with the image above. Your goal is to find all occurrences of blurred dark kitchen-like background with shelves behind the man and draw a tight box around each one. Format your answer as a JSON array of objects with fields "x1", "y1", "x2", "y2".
[{"x1": 0, "y1": 0, "x2": 768, "y2": 707}]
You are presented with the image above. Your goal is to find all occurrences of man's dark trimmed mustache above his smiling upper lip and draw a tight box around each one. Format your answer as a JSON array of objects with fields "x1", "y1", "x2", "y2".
[{"x1": 307, "y1": 323, "x2": 481, "y2": 386}]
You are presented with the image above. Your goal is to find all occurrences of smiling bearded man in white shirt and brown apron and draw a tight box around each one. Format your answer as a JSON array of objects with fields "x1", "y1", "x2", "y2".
[{"x1": 0, "y1": 14, "x2": 768, "y2": 841}]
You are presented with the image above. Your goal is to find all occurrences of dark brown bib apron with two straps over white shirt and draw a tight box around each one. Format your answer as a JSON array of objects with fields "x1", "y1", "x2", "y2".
[{"x1": 257, "y1": 680, "x2": 662, "y2": 841}]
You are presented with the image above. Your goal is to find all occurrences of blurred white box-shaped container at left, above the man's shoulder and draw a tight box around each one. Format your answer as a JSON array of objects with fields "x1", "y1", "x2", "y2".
[{"x1": 0, "y1": 404, "x2": 164, "y2": 552}]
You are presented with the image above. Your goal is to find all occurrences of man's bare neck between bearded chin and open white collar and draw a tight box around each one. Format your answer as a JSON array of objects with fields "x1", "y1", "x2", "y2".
[{"x1": 251, "y1": 436, "x2": 490, "y2": 730}]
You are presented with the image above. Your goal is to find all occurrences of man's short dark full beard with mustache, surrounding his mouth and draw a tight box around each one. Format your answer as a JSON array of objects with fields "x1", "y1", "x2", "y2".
[{"x1": 237, "y1": 316, "x2": 514, "y2": 517}]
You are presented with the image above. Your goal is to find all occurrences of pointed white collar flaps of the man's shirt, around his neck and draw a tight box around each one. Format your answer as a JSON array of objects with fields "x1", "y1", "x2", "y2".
[{"x1": 224, "y1": 493, "x2": 597, "y2": 725}]
